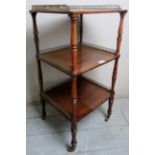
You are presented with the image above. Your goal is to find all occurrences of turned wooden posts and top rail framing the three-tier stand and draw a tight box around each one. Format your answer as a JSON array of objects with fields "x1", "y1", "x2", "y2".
[{"x1": 30, "y1": 7, "x2": 127, "y2": 151}]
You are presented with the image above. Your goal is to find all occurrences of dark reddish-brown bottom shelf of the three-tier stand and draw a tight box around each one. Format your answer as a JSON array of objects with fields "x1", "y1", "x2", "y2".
[{"x1": 42, "y1": 77, "x2": 112, "y2": 121}]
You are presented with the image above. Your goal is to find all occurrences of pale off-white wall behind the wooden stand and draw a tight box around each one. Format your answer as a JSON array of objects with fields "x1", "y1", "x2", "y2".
[{"x1": 26, "y1": 0, "x2": 129, "y2": 103}]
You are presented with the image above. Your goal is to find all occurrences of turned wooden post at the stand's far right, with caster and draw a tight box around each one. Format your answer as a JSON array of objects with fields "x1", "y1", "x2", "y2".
[{"x1": 106, "y1": 11, "x2": 127, "y2": 121}]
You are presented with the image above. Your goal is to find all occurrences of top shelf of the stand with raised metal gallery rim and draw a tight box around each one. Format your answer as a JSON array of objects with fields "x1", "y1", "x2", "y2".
[{"x1": 31, "y1": 5, "x2": 126, "y2": 14}]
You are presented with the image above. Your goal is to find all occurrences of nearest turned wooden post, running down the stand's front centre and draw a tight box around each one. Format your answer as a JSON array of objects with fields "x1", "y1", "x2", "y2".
[{"x1": 68, "y1": 14, "x2": 78, "y2": 152}]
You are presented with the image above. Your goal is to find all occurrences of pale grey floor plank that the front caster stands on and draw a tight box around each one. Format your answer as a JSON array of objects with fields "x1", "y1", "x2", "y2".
[{"x1": 27, "y1": 127, "x2": 128, "y2": 155}]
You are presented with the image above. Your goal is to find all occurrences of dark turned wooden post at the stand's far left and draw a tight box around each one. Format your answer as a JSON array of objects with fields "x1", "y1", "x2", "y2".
[{"x1": 30, "y1": 11, "x2": 46, "y2": 119}]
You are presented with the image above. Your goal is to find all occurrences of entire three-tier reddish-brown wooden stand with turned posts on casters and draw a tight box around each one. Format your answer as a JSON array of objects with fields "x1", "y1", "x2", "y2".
[{"x1": 30, "y1": 5, "x2": 127, "y2": 152}]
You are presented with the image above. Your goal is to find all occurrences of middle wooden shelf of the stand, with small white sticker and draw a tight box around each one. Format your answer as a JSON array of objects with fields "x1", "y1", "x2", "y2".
[{"x1": 39, "y1": 44, "x2": 117, "y2": 75}]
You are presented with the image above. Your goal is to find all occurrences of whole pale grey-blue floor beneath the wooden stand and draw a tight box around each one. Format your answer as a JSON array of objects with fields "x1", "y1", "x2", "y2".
[{"x1": 27, "y1": 99, "x2": 129, "y2": 155}]
